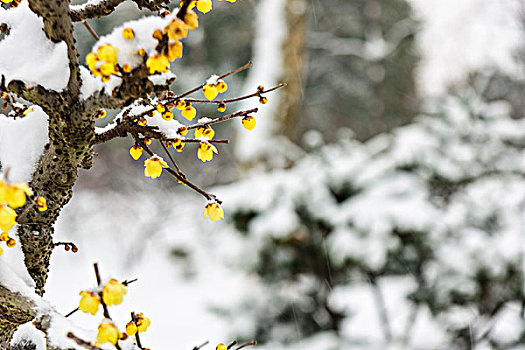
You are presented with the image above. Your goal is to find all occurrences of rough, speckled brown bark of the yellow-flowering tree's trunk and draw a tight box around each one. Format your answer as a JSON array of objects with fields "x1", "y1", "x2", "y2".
[{"x1": 0, "y1": 0, "x2": 167, "y2": 349}]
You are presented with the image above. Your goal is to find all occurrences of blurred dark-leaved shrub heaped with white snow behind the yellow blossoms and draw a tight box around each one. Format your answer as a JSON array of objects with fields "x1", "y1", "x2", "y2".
[{"x1": 214, "y1": 75, "x2": 525, "y2": 349}]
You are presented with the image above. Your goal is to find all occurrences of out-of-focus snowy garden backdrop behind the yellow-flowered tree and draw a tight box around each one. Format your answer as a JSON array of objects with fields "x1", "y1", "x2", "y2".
[{"x1": 21, "y1": 0, "x2": 525, "y2": 350}]
